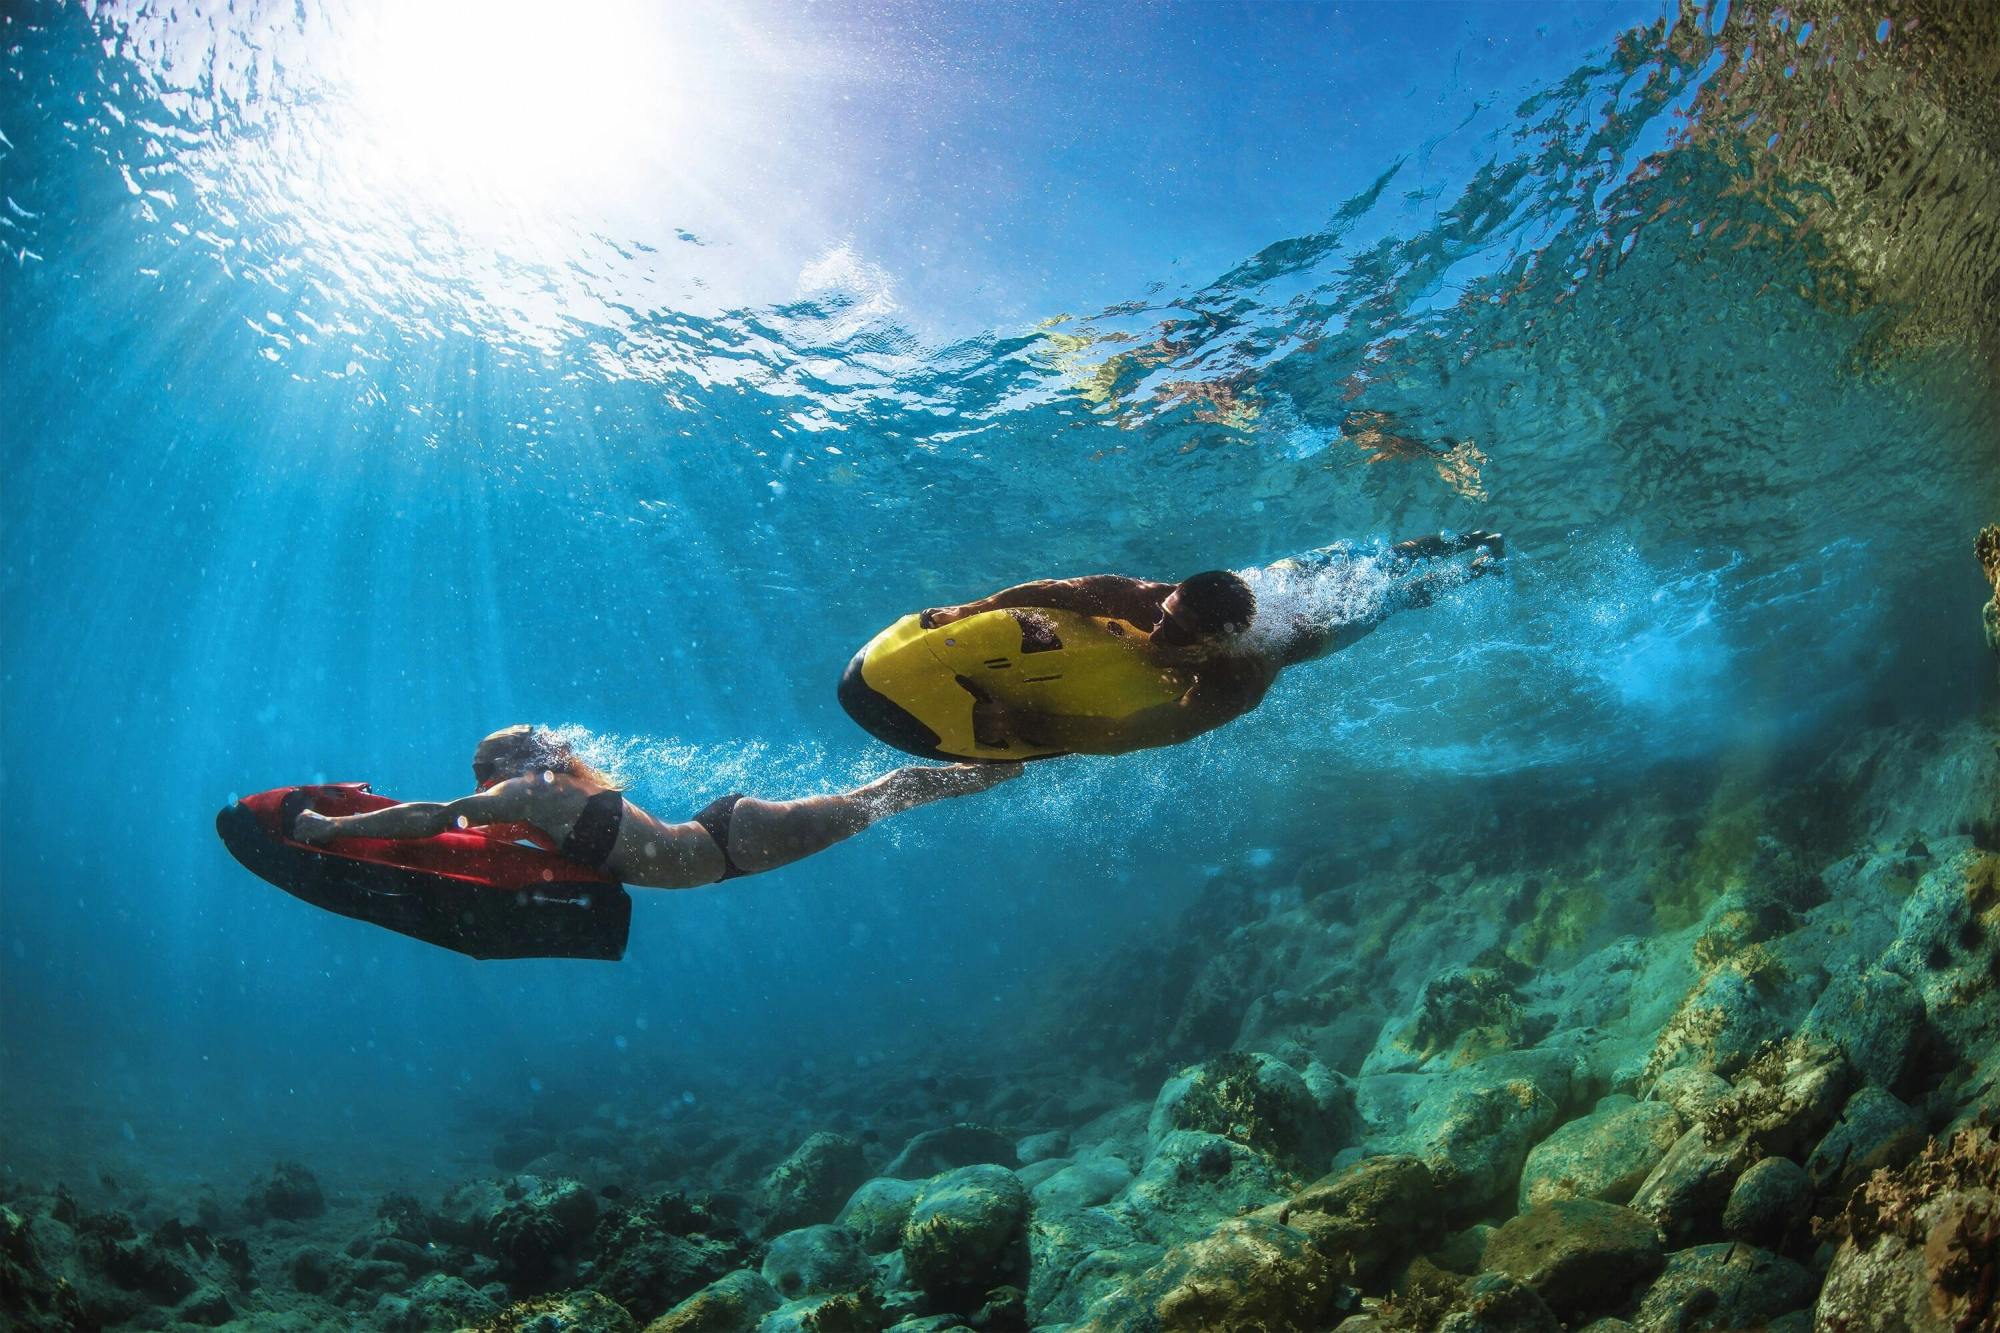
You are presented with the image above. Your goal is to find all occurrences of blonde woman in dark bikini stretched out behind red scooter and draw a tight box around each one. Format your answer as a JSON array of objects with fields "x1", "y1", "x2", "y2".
[{"x1": 294, "y1": 727, "x2": 1020, "y2": 889}]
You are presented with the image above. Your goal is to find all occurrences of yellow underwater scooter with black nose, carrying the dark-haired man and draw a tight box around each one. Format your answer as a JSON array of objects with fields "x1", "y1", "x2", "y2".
[{"x1": 840, "y1": 606, "x2": 1194, "y2": 761}]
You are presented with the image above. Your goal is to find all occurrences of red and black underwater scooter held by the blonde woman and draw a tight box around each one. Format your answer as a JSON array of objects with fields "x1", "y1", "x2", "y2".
[{"x1": 216, "y1": 783, "x2": 632, "y2": 961}]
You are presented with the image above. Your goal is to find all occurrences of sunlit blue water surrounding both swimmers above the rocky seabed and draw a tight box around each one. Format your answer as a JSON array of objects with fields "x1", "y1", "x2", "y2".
[{"x1": 0, "y1": 0, "x2": 2000, "y2": 1183}]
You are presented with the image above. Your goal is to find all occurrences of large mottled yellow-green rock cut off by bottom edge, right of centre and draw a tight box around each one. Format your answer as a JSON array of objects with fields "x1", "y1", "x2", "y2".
[{"x1": 1076, "y1": 1217, "x2": 1342, "y2": 1333}]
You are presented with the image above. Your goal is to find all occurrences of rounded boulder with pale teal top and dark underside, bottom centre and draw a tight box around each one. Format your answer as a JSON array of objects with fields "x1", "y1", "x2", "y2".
[{"x1": 902, "y1": 1165, "x2": 1028, "y2": 1299}]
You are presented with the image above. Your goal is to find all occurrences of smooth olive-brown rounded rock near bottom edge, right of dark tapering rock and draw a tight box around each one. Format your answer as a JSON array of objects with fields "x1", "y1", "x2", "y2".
[{"x1": 1482, "y1": 1199, "x2": 1662, "y2": 1321}]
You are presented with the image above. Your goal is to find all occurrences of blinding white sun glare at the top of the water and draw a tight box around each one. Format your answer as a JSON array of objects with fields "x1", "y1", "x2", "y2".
[{"x1": 336, "y1": 0, "x2": 696, "y2": 224}]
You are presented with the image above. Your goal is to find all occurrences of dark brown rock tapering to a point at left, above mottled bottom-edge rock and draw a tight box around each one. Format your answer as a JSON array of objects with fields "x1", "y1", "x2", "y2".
[{"x1": 1276, "y1": 1153, "x2": 1444, "y2": 1285}]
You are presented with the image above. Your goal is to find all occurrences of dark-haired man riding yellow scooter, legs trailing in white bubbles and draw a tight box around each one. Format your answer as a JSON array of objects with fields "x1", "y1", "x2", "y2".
[{"x1": 920, "y1": 532, "x2": 1506, "y2": 755}]
